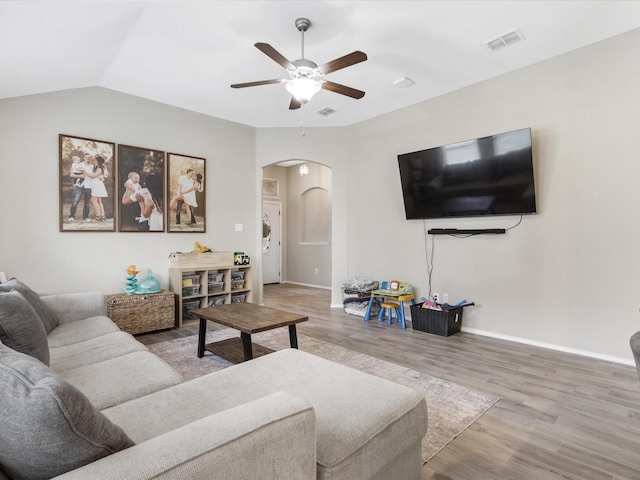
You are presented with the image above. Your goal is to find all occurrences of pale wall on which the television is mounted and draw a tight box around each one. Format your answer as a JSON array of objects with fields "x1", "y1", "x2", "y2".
[{"x1": 257, "y1": 30, "x2": 640, "y2": 363}]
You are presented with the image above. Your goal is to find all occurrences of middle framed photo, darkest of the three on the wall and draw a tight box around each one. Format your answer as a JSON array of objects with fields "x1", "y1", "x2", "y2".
[{"x1": 118, "y1": 145, "x2": 166, "y2": 232}]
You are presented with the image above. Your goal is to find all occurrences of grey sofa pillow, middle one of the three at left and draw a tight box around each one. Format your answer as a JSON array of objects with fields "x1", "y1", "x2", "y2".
[{"x1": 0, "y1": 290, "x2": 49, "y2": 365}]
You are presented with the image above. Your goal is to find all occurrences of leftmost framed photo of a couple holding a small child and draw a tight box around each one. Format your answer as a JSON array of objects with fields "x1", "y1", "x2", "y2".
[{"x1": 59, "y1": 134, "x2": 116, "y2": 232}]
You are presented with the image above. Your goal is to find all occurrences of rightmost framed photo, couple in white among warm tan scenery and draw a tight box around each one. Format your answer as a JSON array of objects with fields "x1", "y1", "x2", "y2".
[{"x1": 167, "y1": 153, "x2": 207, "y2": 233}]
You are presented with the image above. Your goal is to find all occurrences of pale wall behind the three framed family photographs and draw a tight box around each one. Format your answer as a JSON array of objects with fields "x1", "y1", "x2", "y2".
[{"x1": 0, "y1": 88, "x2": 259, "y2": 293}]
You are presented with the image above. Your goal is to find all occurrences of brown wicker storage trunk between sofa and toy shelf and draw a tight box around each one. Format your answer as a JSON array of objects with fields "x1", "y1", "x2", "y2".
[{"x1": 107, "y1": 290, "x2": 176, "y2": 334}]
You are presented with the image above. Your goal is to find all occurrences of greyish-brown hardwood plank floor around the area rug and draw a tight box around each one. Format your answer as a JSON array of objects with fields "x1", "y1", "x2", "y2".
[{"x1": 138, "y1": 284, "x2": 640, "y2": 480}]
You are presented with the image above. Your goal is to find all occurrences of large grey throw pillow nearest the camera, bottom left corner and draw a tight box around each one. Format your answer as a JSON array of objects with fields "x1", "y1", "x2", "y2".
[{"x1": 0, "y1": 344, "x2": 134, "y2": 480}]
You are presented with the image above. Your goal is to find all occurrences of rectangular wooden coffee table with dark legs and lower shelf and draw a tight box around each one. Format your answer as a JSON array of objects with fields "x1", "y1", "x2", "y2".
[{"x1": 189, "y1": 302, "x2": 309, "y2": 363}]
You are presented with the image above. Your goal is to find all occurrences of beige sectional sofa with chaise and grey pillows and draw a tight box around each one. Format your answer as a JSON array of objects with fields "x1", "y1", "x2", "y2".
[{"x1": 0, "y1": 281, "x2": 427, "y2": 480}]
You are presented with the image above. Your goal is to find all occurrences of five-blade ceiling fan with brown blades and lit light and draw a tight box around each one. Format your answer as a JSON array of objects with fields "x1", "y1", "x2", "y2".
[{"x1": 231, "y1": 18, "x2": 367, "y2": 110}]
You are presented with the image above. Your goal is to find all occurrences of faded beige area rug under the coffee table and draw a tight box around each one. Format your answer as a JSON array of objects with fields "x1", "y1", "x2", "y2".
[{"x1": 148, "y1": 329, "x2": 499, "y2": 463}]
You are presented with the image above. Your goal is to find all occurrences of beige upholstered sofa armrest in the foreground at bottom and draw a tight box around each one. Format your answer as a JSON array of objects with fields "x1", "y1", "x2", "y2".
[{"x1": 56, "y1": 392, "x2": 316, "y2": 480}]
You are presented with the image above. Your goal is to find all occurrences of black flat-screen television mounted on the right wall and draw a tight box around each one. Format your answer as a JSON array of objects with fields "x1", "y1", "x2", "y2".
[{"x1": 398, "y1": 128, "x2": 536, "y2": 220}]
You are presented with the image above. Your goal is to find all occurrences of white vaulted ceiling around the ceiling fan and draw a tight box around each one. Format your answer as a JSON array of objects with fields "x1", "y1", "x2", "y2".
[{"x1": 0, "y1": 0, "x2": 640, "y2": 127}]
